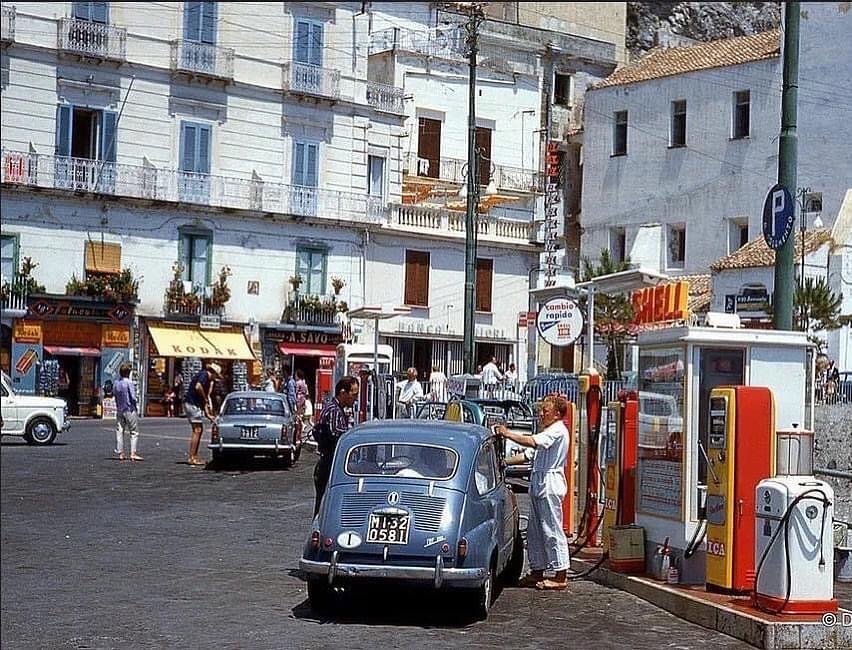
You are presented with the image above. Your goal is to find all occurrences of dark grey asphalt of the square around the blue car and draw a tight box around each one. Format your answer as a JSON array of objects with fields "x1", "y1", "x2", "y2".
[{"x1": 0, "y1": 419, "x2": 750, "y2": 650}]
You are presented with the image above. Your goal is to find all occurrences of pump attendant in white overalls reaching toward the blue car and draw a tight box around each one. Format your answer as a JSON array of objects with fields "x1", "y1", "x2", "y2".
[{"x1": 495, "y1": 396, "x2": 571, "y2": 590}]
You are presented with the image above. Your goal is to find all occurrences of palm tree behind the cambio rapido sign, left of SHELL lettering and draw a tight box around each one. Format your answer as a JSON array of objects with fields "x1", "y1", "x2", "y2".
[{"x1": 581, "y1": 249, "x2": 633, "y2": 379}]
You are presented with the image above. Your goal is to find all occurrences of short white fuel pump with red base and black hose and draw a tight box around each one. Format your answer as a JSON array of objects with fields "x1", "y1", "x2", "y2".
[{"x1": 754, "y1": 429, "x2": 837, "y2": 614}]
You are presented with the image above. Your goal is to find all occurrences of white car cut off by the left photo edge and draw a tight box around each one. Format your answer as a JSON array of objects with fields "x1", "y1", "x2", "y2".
[{"x1": 0, "y1": 372, "x2": 71, "y2": 445}]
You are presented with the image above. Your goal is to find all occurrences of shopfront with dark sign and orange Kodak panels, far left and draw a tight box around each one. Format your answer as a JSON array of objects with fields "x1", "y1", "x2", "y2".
[{"x1": 11, "y1": 296, "x2": 134, "y2": 416}]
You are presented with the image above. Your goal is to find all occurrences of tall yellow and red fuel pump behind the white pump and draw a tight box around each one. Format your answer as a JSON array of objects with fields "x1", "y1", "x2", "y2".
[{"x1": 699, "y1": 386, "x2": 775, "y2": 593}]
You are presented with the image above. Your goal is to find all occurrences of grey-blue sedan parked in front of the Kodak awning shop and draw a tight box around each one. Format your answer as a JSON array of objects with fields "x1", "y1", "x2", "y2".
[{"x1": 207, "y1": 391, "x2": 302, "y2": 466}]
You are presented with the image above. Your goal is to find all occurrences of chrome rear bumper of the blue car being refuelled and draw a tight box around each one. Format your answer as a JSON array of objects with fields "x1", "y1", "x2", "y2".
[{"x1": 299, "y1": 551, "x2": 486, "y2": 589}]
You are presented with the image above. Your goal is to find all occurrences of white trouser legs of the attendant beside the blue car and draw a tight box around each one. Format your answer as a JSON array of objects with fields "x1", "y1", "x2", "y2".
[{"x1": 527, "y1": 492, "x2": 571, "y2": 571}]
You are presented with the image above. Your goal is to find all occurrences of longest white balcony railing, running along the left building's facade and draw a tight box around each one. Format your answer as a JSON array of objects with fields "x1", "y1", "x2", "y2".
[{"x1": 2, "y1": 151, "x2": 385, "y2": 223}]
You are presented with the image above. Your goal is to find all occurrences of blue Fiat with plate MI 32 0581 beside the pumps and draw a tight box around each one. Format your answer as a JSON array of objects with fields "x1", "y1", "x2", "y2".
[{"x1": 299, "y1": 420, "x2": 524, "y2": 618}]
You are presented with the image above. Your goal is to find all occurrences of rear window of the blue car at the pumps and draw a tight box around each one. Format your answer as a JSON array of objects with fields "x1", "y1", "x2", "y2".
[{"x1": 346, "y1": 442, "x2": 459, "y2": 481}]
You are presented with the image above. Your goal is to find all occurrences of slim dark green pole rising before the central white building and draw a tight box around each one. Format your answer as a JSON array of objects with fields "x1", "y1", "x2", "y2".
[{"x1": 463, "y1": 3, "x2": 484, "y2": 374}]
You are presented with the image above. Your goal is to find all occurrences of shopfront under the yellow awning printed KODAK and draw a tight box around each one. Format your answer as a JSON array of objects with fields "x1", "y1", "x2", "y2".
[{"x1": 140, "y1": 319, "x2": 261, "y2": 416}]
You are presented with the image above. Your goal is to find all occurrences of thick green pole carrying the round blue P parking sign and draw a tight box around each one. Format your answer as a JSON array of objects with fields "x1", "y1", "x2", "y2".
[{"x1": 773, "y1": 2, "x2": 804, "y2": 330}]
